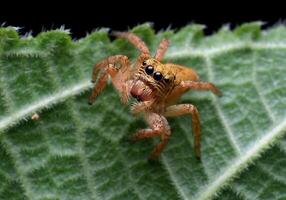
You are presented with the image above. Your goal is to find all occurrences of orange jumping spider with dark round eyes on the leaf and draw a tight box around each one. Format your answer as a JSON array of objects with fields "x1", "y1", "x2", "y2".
[{"x1": 89, "y1": 32, "x2": 220, "y2": 159}]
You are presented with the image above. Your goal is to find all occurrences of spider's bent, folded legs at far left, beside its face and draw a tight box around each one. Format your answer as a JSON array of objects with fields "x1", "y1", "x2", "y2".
[{"x1": 88, "y1": 55, "x2": 131, "y2": 105}]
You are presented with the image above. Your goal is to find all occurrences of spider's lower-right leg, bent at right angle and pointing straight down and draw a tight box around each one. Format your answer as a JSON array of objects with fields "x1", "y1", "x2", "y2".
[{"x1": 164, "y1": 104, "x2": 201, "y2": 159}]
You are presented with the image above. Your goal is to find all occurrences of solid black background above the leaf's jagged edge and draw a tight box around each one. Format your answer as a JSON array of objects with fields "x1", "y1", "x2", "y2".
[{"x1": 0, "y1": 0, "x2": 286, "y2": 38}]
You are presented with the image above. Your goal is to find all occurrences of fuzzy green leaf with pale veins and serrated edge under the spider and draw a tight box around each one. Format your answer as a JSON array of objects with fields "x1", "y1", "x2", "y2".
[{"x1": 0, "y1": 22, "x2": 286, "y2": 200}]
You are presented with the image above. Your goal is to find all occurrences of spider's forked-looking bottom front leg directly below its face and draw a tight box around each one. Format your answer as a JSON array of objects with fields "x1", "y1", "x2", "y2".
[{"x1": 132, "y1": 113, "x2": 171, "y2": 160}]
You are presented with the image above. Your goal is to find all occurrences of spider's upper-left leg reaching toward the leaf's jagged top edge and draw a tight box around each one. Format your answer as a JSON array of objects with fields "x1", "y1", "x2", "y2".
[{"x1": 111, "y1": 31, "x2": 150, "y2": 54}]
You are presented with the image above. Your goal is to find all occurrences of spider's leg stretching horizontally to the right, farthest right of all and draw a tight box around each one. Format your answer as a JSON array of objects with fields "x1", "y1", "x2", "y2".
[{"x1": 180, "y1": 81, "x2": 221, "y2": 96}]
